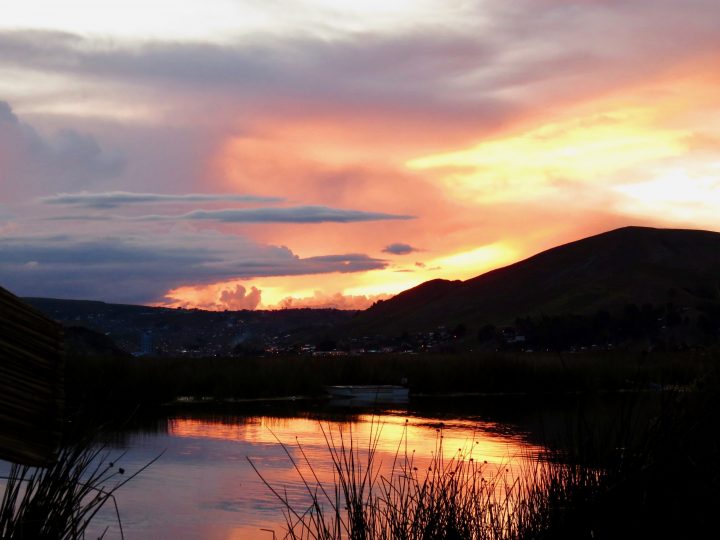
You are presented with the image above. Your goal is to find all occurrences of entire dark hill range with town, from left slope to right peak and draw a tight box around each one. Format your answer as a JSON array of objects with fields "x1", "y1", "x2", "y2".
[{"x1": 19, "y1": 227, "x2": 720, "y2": 356}]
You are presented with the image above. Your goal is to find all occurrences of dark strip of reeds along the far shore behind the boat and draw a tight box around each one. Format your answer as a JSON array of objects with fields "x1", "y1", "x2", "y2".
[{"x1": 66, "y1": 350, "x2": 715, "y2": 416}]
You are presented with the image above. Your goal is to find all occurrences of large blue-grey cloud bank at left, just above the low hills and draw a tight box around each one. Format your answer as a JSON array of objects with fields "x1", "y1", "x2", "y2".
[{"x1": 0, "y1": 233, "x2": 386, "y2": 303}]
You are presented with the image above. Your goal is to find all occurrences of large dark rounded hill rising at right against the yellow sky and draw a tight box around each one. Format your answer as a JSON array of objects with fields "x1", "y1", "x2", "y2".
[{"x1": 349, "y1": 227, "x2": 720, "y2": 335}]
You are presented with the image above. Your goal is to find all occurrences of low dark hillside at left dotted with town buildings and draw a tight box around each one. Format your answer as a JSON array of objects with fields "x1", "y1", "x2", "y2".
[{"x1": 24, "y1": 298, "x2": 355, "y2": 356}]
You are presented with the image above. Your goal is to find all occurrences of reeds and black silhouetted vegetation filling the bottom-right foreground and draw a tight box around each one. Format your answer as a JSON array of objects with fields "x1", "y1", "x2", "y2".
[{"x1": 253, "y1": 372, "x2": 720, "y2": 540}]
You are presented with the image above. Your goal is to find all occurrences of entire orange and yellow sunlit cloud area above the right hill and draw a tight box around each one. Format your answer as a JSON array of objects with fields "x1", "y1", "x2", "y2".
[{"x1": 162, "y1": 60, "x2": 720, "y2": 309}]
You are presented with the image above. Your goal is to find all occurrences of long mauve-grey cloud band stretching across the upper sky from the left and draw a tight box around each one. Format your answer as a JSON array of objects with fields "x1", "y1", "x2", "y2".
[{"x1": 0, "y1": 31, "x2": 507, "y2": 125}]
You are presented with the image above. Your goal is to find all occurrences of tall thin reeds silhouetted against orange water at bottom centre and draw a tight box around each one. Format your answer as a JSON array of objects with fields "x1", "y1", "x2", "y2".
[{"x1": 248, "y1": 425, "x2": 607, "y2": 540}]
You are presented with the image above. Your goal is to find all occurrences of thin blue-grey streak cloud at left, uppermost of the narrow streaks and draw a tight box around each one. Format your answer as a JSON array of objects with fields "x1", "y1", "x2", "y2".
[{"x1": 40, "y1": 191, "x2": 282, "y2": 209}]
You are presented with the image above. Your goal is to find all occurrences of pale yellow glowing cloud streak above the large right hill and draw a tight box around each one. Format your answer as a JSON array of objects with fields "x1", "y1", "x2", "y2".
[{"x1": 407, "y1": 108, "x2": 690, "y2": 203}]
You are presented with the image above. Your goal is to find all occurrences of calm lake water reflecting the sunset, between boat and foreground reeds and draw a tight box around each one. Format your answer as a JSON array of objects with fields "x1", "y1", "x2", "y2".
[{"x1": 3, "y1": 397, "x2": 648, "y2": 540}]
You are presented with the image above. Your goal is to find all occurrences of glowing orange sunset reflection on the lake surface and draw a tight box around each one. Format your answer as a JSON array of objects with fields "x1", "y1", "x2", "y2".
[{"x1": 163, "y1": 411, "x2": 542, "y2": 540}]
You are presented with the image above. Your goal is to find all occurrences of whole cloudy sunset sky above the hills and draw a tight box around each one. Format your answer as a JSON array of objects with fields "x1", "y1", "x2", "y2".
[{"x1": 0, "y1": 0, "x2": 720, "y2": 309}]
